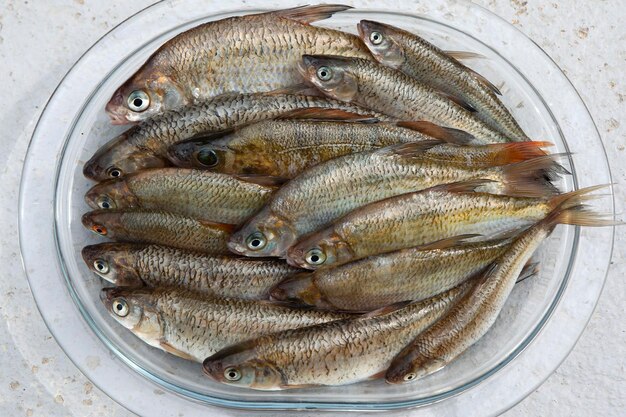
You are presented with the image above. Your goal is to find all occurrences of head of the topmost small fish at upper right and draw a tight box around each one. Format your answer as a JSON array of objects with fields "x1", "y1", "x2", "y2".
[{"x1": 357, "y1": 20, "x2": 406, "y2": 69}]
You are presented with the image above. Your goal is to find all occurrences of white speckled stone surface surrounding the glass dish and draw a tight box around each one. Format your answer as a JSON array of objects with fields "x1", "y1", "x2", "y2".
[{"x1": 0, "y1": 0, "x2": 626, "y2": 417}]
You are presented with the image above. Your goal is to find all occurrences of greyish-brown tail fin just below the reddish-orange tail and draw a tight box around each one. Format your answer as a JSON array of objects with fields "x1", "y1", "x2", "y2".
[{"x1": 499, "y1": 154, "x2": 564, "y2": 198}]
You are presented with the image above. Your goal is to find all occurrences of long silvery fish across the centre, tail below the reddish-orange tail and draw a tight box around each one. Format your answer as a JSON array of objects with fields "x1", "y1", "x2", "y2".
[{"x1": 228, "y1": 145, "x2": 558, "y2": 256}]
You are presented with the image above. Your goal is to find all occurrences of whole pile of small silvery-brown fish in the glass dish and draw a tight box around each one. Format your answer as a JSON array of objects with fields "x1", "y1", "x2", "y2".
[{"x1": 82, "y1": 5, "x2": 613, "y2": 390}]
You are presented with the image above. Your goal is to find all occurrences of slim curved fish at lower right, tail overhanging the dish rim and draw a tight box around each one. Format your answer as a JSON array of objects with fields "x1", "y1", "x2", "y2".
[{"x1": 385, "y1": 187, "x2": 616, "y2": 384}]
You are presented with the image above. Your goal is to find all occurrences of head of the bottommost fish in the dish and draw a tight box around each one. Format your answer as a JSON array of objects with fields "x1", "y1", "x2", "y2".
[{"x1": 202, "y1": 340, "x2": 286, "y2": 390}]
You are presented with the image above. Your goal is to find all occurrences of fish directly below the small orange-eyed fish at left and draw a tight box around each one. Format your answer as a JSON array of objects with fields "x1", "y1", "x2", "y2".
[{"x1": 81, "y1": 242, "x2": 302, "y2": 300}]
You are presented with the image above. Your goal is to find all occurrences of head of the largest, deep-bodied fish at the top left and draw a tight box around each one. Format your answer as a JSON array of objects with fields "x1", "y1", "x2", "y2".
[{"x1": 105, "y1": 65, "x2": 187, "y2": 125}]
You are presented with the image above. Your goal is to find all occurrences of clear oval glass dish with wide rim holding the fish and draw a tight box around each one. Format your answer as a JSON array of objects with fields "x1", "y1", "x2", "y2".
[{"x1": 20, "y1": 0, "x2": 613, "y2": 415}]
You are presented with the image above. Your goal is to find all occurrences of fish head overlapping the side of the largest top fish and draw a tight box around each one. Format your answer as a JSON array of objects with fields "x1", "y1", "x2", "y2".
[{"x1": 298, "y1": 55, "x2": 359, "y2": 102}]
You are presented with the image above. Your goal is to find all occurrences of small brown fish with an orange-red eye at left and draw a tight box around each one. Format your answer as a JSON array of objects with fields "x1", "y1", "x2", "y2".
[{"x1": 82, "y1": 209, "x2": 235, "y2": 255}]
